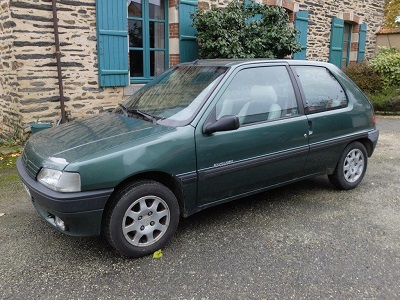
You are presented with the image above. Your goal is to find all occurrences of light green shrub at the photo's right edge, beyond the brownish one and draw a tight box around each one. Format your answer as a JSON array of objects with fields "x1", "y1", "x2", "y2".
[{"x1": 369, "y1": 47, "x2": 400, "y2": 88}]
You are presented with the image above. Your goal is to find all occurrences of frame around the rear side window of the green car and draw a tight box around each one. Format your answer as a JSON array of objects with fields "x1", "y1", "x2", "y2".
[{"x1": 290, "y1": 65, "x2": 350, "y2": 115}]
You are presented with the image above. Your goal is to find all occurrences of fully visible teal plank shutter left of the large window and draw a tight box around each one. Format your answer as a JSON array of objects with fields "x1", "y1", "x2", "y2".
[{"x1": 96, "y1": 0, "x2": 129, "y2": 86}]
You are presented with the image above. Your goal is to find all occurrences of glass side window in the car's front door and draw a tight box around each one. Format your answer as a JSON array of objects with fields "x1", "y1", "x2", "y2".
[{"x1": 216, "y1": 66, "x2": 298, "y2": 124}]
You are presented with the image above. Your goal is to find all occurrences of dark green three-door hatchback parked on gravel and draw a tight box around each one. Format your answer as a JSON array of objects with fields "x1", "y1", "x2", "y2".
[{"x1": 17, "y1": 60, "x2": 379, "y2": 257}]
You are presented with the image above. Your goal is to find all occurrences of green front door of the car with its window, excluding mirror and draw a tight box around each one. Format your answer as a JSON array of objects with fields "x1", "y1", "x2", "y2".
[{"x1": 195, "y1": 64, "x2": 308, "y2": 206}]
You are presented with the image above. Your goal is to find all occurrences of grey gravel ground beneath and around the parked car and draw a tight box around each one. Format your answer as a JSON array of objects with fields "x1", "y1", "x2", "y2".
[{"x1": 0, "y1": 117, "x2": 400, "y2": 299}]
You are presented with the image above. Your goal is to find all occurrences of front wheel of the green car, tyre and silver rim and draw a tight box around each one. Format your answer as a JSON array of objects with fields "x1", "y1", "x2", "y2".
[{"x1": 103, "y1": 181, "x2": 179, "y2": 258}]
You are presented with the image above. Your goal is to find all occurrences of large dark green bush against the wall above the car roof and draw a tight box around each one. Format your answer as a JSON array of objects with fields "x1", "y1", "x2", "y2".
[{"x1": 192, "y1": 0, "x2": 301, "y2": 58}]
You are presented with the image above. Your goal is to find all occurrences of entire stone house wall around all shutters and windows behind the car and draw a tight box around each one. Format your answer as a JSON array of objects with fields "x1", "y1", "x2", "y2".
[{"x1": 0, "y1": 0, "x2": 384, "y2": 138}]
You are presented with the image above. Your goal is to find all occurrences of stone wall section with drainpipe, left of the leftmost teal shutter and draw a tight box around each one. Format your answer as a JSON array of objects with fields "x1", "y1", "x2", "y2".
[{"x1": 0, "y1": 0, "x2": 123, "y2": 139}]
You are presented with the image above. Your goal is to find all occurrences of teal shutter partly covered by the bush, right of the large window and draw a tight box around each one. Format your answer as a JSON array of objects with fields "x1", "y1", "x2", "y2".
[{"x1": 179, "y1": 0, "x2": 198, "y2": 62}]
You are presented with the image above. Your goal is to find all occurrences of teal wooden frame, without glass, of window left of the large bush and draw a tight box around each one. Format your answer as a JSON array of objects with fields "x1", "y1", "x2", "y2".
[{"x1": 126, "y1": 0, "x2": 169, "y2": 83}]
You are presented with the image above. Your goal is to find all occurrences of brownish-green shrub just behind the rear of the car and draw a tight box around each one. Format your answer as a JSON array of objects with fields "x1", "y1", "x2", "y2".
[{"x1": 344, "y1": 62, "x2": 383, "y2": 93}]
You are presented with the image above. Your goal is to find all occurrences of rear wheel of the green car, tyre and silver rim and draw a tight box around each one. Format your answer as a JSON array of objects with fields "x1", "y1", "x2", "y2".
[{"x1": 328, "y1": 142, "x2": 368, "y2": 190}]
